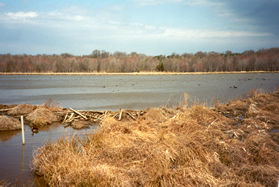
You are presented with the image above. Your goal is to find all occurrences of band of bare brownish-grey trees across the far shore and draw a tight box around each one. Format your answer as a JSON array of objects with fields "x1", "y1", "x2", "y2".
[{"x1": 0, "y1": 48, "x2": 279, "y2": 72}]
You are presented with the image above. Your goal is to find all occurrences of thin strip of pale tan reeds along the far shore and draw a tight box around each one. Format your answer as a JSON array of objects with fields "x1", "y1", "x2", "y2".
[{"x1": 0, "y1": 71, "x2": 279, "y2": 75}]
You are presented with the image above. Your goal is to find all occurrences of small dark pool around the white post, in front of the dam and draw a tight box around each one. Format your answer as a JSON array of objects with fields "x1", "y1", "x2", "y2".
[{"x1": 0, "y1": 124, "x2": 97, "y2": 186}]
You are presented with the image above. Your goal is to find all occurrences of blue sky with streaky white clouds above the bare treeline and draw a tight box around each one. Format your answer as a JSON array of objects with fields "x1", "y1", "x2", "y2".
[{"x1": 0, "y1": 0, "x2": 279, "y2": 55}]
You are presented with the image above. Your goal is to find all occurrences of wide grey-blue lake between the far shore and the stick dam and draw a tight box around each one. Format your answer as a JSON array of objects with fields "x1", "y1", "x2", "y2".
[{"x1": 0, "y1": 73, "x2": 279, "y2": 110}]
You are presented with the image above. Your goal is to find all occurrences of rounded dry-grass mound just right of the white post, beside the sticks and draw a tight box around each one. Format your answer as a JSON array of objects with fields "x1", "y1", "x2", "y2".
[{"x1": 26, "y1": 107, "x2": 61, "y2": 127}]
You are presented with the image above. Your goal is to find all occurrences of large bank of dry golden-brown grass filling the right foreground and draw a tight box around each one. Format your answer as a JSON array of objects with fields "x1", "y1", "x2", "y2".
[{"x1": 33, "y1": 91, "x2": 279, "y2": 186}]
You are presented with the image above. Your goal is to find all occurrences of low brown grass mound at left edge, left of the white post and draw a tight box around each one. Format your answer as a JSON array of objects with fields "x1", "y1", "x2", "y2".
[{"x1": 0, "y1": 116, "x2": 21, "y2": 131}]
